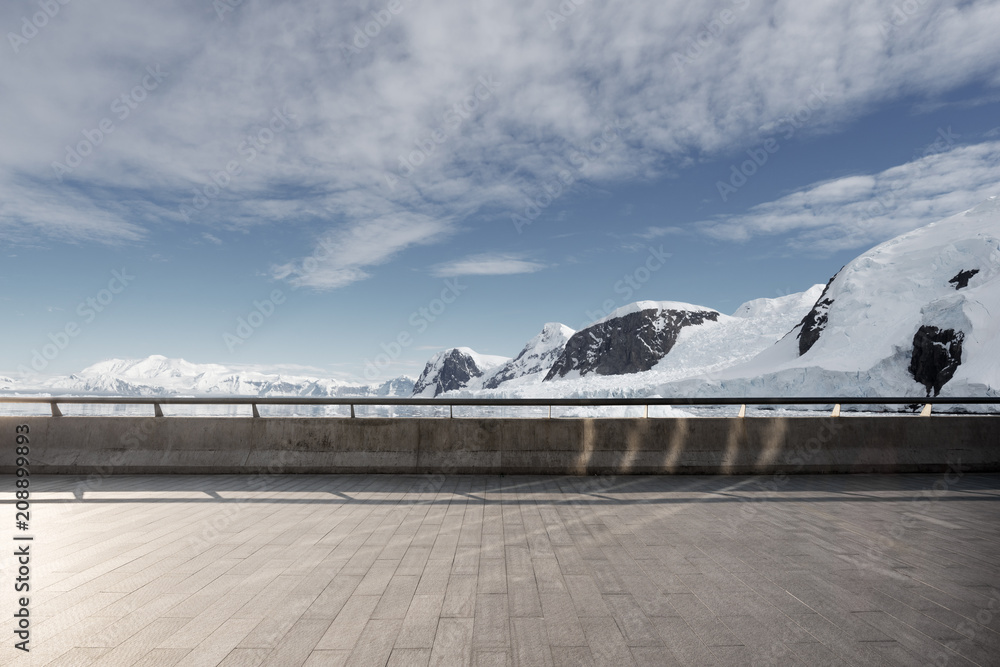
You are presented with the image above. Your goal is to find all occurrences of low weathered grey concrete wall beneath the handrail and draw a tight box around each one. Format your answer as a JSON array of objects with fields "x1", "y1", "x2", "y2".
[{"x1": 0, "y1": 416, "x2": 1000, "y2": 475}]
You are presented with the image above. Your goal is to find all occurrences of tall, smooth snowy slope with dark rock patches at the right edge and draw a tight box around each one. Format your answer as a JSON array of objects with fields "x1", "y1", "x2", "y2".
[{"x1": 680, "y1": 197, "x2": 1000, "y2": 396}]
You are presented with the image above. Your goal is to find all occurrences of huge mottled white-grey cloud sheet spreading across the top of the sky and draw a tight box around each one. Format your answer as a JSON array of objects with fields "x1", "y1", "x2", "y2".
[{"x1": 0, "y1": 0, "x2": 1000, "y2": 280}]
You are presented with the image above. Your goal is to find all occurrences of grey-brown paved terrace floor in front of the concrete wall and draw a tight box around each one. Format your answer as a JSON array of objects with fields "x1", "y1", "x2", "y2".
[{"x1": 0, "y1": 473, "x2": 1000, "y2": 667}]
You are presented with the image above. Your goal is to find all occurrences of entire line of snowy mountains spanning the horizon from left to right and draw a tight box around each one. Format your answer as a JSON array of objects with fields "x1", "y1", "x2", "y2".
[{"x1": 0, "y1": 197, "x2": 1000, "y2": 398}]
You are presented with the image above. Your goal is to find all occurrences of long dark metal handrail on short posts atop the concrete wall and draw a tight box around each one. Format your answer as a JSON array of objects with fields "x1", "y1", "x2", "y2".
[{"x1": 0, "y1": 396, "x2": 1000, "y2": 418}]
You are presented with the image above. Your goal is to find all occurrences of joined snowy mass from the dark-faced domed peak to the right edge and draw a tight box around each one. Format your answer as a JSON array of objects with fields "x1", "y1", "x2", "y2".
[{"x1": 424, "y1": 197, "x2": 1000, "y2": 398}]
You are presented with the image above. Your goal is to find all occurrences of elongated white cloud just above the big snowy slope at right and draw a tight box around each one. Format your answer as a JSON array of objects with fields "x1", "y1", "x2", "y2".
[{"x1": 699, "y1": 141, "x2": 1000, "y2": 253}]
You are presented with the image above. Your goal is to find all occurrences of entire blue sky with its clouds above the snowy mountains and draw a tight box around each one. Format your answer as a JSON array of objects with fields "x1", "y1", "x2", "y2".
[{"x1": 0, "y1": 0, "x2": 1000, "y2": 380}]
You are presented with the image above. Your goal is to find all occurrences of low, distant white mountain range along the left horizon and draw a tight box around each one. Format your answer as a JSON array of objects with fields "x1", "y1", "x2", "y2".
[{"x1": 15, "y1": 355, "x2": 413, "y2": 397}]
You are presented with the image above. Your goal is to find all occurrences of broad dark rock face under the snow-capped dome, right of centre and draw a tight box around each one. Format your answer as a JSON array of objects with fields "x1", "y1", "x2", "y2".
[{"x1": 545, "y1": 309, "x2": 719, "y2": 380}]
